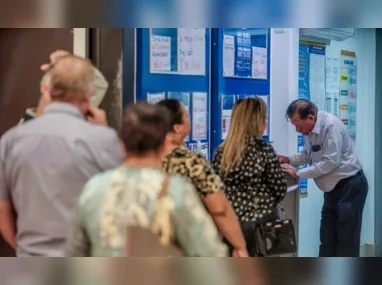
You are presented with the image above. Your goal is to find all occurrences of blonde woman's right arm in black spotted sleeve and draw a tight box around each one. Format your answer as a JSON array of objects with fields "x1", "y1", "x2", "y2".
[{"x1": 264, "y1": 145, "x2": 287, "y2": 204}]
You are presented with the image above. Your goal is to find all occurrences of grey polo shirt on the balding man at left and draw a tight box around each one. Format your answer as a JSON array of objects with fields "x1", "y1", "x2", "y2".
[{"x1": 0, "y1": 103, "x2": 124, "y2": 256}]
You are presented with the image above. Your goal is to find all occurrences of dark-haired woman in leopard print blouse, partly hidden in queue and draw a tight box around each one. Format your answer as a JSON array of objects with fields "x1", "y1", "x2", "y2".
[{"x1": 158, "y1": 99, "x2": 248, "y2": 257}]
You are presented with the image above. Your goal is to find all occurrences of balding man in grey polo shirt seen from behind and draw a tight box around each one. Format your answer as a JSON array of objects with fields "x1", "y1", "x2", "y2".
[{"x1": 0, "y1": 55, "x2": 124, "y2": 256}]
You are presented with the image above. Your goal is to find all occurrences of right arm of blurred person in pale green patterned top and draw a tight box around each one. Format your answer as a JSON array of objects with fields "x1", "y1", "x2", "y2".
[{"x1": 173, "y1": 182, "x2": 227, "y2": 257}]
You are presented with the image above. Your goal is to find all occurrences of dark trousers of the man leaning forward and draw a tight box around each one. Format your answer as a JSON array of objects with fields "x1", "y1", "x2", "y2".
[{"x1": 319, "y1": 170, "x2": 368, "y2": 257}]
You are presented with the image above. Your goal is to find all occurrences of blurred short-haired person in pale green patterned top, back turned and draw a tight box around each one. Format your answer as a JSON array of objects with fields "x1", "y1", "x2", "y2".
[{"x1": 67, "y1": 103, "x2": 227, "y2": 257}]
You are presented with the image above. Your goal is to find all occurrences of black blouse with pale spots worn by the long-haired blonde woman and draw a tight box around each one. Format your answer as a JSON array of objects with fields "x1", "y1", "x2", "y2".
[{"x1": 212, "y1": 139, "x2": 287, "y2": 222}]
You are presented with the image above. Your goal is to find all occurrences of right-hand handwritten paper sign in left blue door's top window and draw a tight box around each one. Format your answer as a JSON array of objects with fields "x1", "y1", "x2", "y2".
[{"x1": 178, "y1": 28, "x2": 206, "y2": 75}]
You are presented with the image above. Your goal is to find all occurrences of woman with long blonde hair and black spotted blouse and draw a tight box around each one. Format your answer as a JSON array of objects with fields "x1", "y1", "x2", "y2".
[{"x1": 212, "y1": 97, "x2": 287, "y2": 256}]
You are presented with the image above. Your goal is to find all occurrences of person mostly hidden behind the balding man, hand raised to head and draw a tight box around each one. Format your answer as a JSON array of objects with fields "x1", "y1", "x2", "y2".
[{"x1": 20, "y1": 50, "x2": 109, "y2": 123}]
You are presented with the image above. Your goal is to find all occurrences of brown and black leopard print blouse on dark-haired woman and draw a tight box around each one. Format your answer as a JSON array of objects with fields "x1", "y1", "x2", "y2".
[{"x1": 163, "y1": 146, "x2": 224, "y2": 198}]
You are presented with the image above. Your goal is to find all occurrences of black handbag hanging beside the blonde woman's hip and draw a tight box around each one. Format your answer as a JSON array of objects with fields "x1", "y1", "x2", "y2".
[{"x1": 255, "y1": 205, "x2": 297, "y2": 257}]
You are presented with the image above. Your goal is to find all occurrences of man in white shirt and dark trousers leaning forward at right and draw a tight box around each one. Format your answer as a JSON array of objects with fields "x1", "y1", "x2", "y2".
[{"x1": 279, "y1": 99, "x2": 368, "y2": 257}]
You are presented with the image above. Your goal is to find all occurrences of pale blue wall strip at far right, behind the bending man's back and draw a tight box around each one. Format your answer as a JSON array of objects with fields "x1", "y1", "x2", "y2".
[{"x1": 327, "y1": 29, "x2": 376, "y2": 245}]
